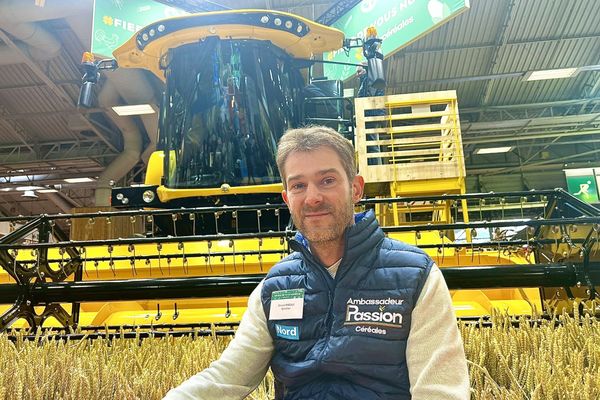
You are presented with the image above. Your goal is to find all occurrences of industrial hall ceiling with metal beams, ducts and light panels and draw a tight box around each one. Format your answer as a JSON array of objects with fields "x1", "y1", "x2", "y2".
[{"x1": 0, "y1": 0, "x2": 600, "y2": 215}]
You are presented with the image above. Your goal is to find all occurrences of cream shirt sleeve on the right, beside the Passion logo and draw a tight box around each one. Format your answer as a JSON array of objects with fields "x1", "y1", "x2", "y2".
[{"x1": 406, "y1": 265, "x2": 470, "y2": 400}]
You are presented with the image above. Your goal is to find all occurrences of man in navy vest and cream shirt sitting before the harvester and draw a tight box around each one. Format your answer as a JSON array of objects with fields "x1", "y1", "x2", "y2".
[{"x1": 166, "y1": 127, "x2": 469, "y2": 400}]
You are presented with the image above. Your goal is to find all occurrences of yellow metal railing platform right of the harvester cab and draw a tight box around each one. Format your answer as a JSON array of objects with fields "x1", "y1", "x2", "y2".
[{"x1": 355, "y1": 91, "x2": 468, "y2": 224}]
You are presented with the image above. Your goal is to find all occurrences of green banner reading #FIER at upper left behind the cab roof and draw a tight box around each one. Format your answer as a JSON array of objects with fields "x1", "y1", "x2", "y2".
[{"x1": 91, "y1": 0, "x2": 187, "y2": 57}]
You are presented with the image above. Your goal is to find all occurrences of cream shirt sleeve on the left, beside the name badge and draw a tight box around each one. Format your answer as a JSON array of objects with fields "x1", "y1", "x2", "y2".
[{"x1": 163, "y1": 282, "x2": 274, "y2": 400}]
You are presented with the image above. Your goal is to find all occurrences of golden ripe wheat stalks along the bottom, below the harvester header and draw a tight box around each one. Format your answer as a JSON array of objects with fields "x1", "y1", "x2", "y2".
[{"x1": 0, "y1": 315, "x2": 600, "y2": 400}]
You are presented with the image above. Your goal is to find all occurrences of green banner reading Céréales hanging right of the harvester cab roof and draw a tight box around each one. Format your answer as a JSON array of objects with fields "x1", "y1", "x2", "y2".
[{"x1": 323, "y1": 0, "x2": 469, "y2": 79}]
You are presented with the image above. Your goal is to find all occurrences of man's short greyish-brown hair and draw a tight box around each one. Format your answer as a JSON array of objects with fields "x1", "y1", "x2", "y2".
[{"x1": 277, "y1": 126, "x2": 356, "y2": 189}]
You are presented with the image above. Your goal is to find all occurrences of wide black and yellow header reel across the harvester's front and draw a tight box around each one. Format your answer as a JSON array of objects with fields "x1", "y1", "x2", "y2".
[{"x1": 0, "y1": 190, "x2": 600, "y2": 330}]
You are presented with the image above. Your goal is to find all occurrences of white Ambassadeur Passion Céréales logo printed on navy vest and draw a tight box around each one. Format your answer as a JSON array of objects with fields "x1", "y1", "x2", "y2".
[{"x1": 344, "y1": 297, "x2": 404, "y2": 335}]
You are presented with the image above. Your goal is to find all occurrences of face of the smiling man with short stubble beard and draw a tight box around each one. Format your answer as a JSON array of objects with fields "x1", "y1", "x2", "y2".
[{"x1": 282, "y1": 146, "x2": 364, "y2": 243}]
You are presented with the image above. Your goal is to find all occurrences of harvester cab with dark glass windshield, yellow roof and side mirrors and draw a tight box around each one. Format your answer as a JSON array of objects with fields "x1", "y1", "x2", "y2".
[{"x1": 80, "y1": 10, "x2": 384, "y2": 238}]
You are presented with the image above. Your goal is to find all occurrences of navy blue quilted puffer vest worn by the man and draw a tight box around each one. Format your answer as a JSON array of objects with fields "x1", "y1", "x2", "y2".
[{"x1": 261, "y1": 211, "x2": 433, "y2": 400}]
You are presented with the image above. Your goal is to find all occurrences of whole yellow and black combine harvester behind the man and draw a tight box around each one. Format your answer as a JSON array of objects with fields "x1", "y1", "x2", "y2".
[{"x1": 0, "y1": 10, "x2": 600, "y2": 336}]
